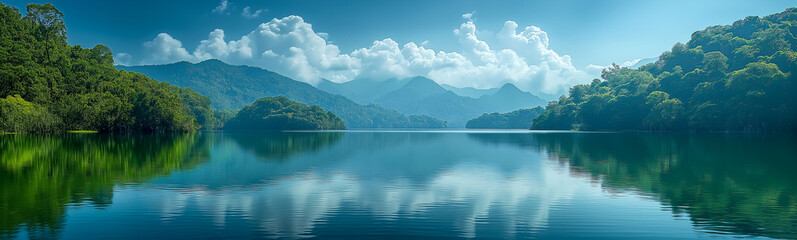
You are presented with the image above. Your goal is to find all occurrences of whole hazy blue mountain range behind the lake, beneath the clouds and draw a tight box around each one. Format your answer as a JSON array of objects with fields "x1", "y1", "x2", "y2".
[{"x1": 124, "y1": 60, "x2": 545, "y2": 128}]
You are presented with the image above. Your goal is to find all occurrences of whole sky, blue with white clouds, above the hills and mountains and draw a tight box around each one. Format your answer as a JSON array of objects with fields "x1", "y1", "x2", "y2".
[{"x1": 5, "y1": 0, "x2": 797, "y2": 94}]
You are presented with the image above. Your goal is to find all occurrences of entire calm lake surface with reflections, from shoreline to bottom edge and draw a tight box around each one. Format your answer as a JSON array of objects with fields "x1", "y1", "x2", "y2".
[{"x1": 0, "y1": 130, "x2": 797, "y2": 239}]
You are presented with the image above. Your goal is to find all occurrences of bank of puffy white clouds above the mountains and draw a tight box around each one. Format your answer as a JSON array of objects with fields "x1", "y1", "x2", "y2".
[{"x1": 134, "y1": 13, "x2": 600, "y2": 96}]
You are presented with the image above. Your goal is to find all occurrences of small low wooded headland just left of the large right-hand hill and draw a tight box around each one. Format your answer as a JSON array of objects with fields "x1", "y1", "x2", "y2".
[{"x1": 465, "y1": 107, "x2": 545, "y2": 129}]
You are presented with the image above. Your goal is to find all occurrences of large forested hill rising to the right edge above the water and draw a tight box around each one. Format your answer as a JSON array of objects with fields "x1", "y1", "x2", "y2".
[{"x1": 532, "y1": 8, "x2": 797, "y2": 132}]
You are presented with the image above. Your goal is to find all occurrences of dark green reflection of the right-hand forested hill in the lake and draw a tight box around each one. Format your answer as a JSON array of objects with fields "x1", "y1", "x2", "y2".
[{"x1": 518, "y1": 134, "x2": 797, "y2": 238}]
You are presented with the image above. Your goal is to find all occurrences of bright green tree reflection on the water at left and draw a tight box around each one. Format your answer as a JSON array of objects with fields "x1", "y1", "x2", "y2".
[{"x1": 0, "y1": 134, "x2": 209, "y2": 237}]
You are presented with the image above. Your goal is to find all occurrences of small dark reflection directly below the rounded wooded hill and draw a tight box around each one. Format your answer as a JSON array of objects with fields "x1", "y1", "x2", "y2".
[{"x1": 225, "y1": 132, "x2": 343, "y2": 161}]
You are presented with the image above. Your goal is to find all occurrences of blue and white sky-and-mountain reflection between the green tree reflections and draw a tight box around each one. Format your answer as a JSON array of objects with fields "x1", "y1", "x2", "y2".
[{"x1": 152, "y1": 132, "x2": 577, "y2": 238}]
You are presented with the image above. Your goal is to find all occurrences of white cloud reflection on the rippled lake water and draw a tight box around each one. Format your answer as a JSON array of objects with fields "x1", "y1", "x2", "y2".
[{"x1": 154, "y1": 159, "x2": 575, "y2": 238}]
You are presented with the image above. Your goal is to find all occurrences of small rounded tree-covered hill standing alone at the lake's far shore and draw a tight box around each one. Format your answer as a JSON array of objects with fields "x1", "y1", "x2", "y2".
[{"x1": 224, "y1": 96, "x2": 346, "y2": 130}]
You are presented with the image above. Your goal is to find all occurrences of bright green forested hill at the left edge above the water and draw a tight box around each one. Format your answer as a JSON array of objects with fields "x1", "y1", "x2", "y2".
[{"x1": 0, "y1": 4, "x2": 215, "y2": 132}]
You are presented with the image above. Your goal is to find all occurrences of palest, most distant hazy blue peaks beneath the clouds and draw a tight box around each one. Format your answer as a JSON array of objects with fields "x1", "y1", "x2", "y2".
[{"x1": 317, "y1": 77, "x2": 546, "y2": 127}]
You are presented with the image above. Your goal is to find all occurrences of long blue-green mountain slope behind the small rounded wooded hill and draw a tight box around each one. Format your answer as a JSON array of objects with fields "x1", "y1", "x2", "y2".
[{"x1": 124, "y1": 60, "x2": 446, "y2": 128}]
